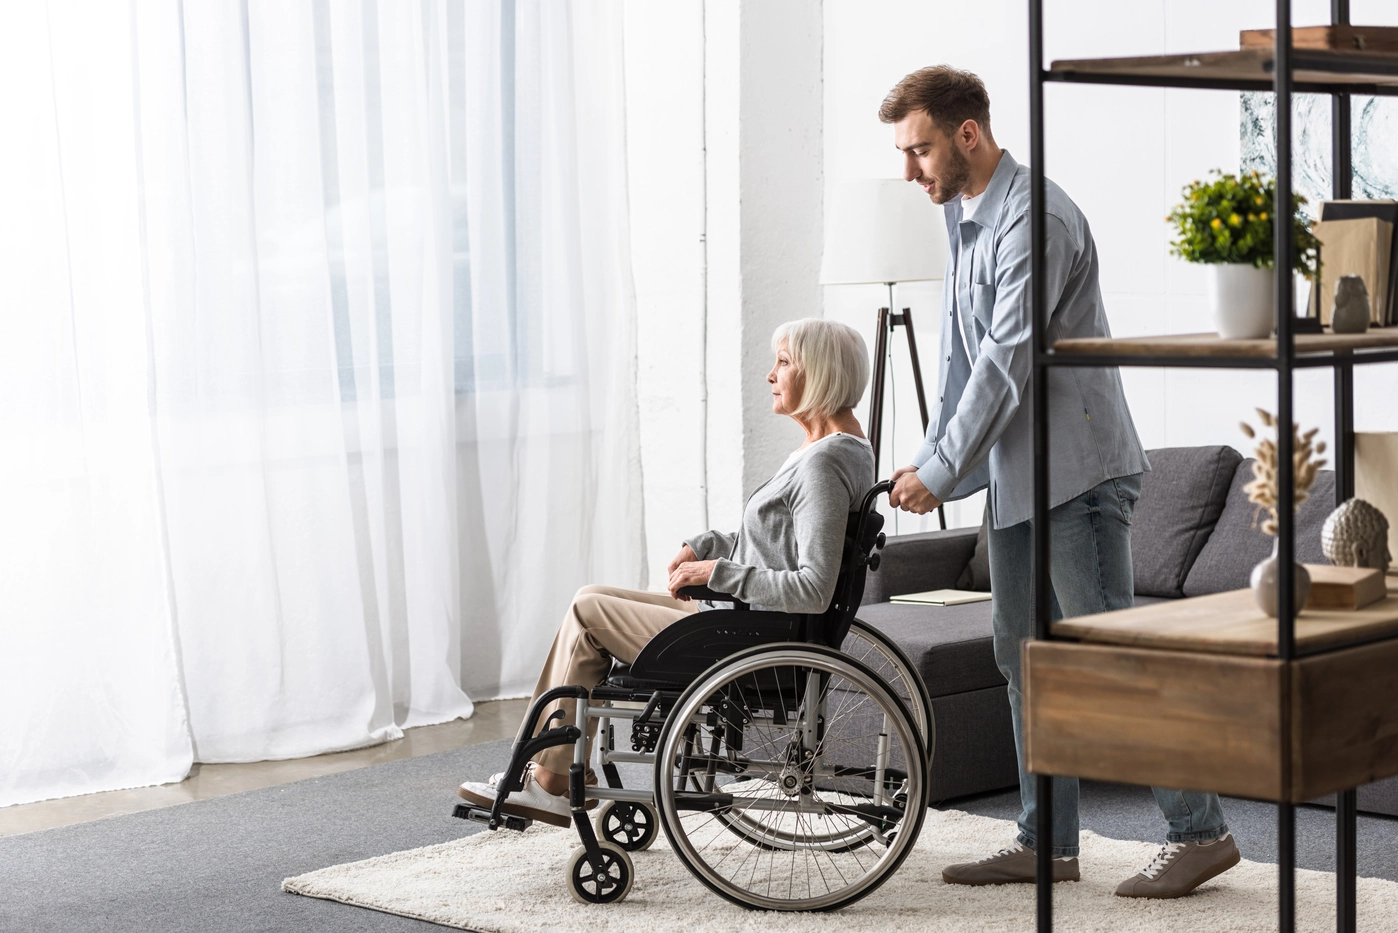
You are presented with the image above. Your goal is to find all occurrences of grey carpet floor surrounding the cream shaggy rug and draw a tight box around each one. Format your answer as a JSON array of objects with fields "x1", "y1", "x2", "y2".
[{"x1": 0, "y1": 741, "x2": 1398, "y2": 933}]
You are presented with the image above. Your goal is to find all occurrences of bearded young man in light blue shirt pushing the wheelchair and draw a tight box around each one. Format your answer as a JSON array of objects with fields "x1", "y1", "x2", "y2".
[{"x1": 879, "y1": 66, "x2": 1240, "y2": 898}]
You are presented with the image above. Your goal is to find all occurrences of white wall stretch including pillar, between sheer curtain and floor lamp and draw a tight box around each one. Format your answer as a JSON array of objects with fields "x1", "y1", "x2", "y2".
[{"x1": 625, "y1": 0, "x2": 823, "y2": 586}]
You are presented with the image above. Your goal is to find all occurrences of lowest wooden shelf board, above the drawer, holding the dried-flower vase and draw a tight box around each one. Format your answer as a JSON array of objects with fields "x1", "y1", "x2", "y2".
[{"x1": 1053, "y1": 576, "x2": 1398, "y2": 657}]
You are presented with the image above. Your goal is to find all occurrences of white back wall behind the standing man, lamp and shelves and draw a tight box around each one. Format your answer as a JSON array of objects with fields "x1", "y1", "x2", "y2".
[{"x1": 825, "y1": 0, "x2": 1398, "y2": 511}]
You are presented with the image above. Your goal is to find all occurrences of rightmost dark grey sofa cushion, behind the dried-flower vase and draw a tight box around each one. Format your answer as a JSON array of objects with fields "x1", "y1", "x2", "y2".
[{"x1": 1184, "y1": 459, "x2": 1335, "y2": 596}]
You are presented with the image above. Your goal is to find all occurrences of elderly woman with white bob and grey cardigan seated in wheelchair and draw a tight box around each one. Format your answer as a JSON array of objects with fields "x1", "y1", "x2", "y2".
[{"x1": 459, "y1": 318, "x2": 874, "y2": 827}]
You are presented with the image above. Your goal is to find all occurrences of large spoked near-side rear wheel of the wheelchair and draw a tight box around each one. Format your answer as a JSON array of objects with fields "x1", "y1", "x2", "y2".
[{"x1": 656, "y1": 643, "x2": 927, "y2": 911}]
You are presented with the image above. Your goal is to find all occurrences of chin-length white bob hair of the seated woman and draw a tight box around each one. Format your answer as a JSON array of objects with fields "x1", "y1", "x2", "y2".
[{"x1": 772, "y1": 318, "x2": 870, "y2": 418}]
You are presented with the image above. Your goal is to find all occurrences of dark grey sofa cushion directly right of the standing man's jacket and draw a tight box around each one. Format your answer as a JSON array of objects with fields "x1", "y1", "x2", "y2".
[{"x1": 1131, "y1": 446, "x2": 1243, "y2": 599}]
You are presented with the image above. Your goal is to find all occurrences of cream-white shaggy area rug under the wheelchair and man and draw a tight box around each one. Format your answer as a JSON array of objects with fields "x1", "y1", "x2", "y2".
[{"x1": 282, "y1": 810, "x2": 1398, "y2": 933}]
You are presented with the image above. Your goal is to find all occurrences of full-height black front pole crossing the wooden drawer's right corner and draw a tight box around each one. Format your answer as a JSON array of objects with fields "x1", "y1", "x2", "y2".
[{"x1": 1272, "y1": 0, "x2": 1299, "y2": 933}]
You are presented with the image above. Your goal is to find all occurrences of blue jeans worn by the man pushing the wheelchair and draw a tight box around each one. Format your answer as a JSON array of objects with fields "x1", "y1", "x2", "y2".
[{"x1": 990, "y1": 473, "x2": 1227, "y2": 856}]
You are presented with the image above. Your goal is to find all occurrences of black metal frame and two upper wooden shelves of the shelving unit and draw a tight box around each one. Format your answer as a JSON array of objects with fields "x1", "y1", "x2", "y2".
[{"x1": 1026, "y1": 0, "x2": 1398, "y2": 933}]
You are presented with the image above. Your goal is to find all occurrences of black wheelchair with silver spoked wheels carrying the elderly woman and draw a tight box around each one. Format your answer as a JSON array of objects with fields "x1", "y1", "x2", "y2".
[{"x1": 453, "y1": 481, "x2": 935, "y2": 911}]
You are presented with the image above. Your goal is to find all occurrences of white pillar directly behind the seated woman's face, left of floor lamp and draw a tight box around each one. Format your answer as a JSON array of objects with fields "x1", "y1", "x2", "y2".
[{"x1": 705, "y1": 0, "x2": 823, "y2": 527}]
